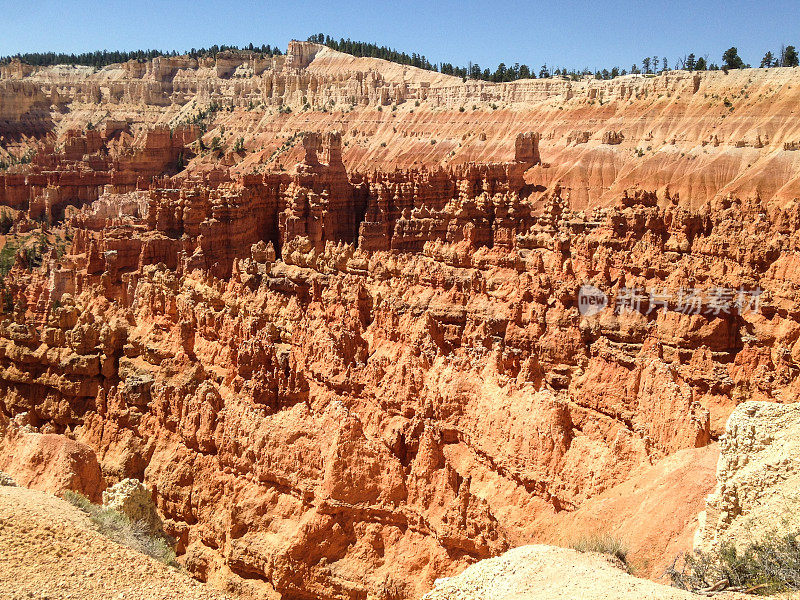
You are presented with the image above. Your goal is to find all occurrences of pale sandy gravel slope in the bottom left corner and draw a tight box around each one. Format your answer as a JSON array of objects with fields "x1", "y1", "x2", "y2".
[{"x1": 0, "y1": 487, "x2": 231, "y2": 600}]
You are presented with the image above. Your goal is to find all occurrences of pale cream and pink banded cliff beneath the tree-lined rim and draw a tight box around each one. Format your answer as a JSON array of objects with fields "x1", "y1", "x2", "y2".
[{"x1": 0, "y1": 42, "x2": 800, "y2": 208}]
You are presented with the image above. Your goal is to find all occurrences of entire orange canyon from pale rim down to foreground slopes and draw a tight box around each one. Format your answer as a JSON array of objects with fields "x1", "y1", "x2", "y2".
[{"x1": 0, "y1": 42, "x2": 800, "y2": 600}]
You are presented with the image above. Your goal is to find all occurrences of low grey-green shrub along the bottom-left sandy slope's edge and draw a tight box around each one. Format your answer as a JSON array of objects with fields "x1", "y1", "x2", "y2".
[{"x1": 64, "y1": 491, "x2": 179, "y2": 567}]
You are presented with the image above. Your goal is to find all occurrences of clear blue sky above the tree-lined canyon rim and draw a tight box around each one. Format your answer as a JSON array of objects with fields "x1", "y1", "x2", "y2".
[{"x1": 0, "y1": 0, "x2": 800, "y2": 69}]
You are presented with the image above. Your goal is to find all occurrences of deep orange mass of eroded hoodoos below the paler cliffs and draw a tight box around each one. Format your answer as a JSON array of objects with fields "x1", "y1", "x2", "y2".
[{"x1": 0, "y1": 144, "x2": 800, "y2": 598}]
